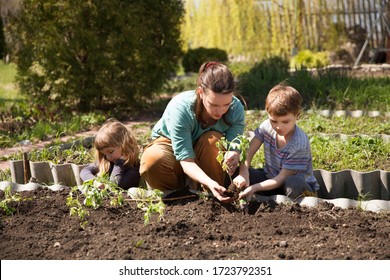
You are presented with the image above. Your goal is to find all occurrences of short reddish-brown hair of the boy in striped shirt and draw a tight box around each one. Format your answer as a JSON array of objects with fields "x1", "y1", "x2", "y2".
[{"x1": 265, "y1": 84, "x2": 302, "y2": 117}]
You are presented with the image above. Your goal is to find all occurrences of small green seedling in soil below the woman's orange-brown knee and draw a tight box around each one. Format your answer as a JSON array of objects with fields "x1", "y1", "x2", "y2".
[{"x1": 131, "y1": 188, "x2": 165, "y2": 225}]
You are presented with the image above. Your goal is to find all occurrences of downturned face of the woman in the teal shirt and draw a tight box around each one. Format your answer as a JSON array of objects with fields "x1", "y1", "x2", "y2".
[{"x1": 199, "y1": 88, "x2": 233, "y2": 120}]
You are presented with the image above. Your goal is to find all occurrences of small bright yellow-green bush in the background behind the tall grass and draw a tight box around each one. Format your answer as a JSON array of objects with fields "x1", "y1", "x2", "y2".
[{"x1": 290, "y1": 50, "x2": 329, "y2": 69}]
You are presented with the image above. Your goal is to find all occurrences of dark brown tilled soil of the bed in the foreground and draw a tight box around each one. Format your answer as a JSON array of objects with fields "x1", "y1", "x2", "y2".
[{"x1": 0, "y1": 189, "x2": 390, "y2": 260}]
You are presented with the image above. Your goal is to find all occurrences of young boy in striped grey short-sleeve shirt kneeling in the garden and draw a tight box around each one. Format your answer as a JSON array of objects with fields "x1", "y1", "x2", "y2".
[{"x1": 234, "y1": 85, "x2": 319, "y2": 201}]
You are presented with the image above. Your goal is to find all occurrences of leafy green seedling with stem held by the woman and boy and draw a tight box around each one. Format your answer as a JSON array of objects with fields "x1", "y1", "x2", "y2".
[{"x1": 216, "y1": 135, "x2": 249, "y2": 209}]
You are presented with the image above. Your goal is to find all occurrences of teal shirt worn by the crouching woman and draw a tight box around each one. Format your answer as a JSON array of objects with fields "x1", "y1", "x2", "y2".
[{"x1": 152, "y1": 90, "x2": 245, "y2": 161}]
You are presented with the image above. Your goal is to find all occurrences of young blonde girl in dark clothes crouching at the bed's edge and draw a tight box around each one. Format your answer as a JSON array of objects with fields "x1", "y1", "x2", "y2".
[{"x1": 80, "y1": 119, "x2": 140, "y2": 189}]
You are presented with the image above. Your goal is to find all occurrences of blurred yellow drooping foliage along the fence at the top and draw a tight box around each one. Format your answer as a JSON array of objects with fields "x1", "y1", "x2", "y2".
[{"x1": 182, "y1": 0, "x2": 366, "y2": 61}]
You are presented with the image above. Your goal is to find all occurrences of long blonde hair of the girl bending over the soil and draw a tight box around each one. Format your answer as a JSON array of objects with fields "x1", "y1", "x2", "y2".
[{"x1": 94, "y1": 118, "x2": 139, "y2": 175}]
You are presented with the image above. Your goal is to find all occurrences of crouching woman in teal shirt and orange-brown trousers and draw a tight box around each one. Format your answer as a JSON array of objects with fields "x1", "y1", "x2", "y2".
[{"x1": 140, "y1": 61, "x2": 245, "y2": 202}]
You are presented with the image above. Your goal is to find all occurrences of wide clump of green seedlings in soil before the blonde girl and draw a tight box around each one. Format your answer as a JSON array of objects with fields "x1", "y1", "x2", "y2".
[{"x1": 66, "y1": 175, "x2": 124, "y2": 227}]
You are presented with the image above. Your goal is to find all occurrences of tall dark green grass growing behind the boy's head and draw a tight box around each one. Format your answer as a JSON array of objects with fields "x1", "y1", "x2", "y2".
[{"x1": 238, "y1": 57, "x2": 390, "y2": 112}]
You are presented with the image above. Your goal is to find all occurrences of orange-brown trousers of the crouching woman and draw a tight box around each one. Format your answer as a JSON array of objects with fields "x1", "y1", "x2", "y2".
[{"x1": 140, "y1": 131, "x2": 225, "y2": 191}]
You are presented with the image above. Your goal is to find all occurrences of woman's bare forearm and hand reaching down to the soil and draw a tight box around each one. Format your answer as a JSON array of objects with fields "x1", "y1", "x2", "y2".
[{"x1": 180, "y1": 159, "x2": 232, "y2": 203}]
